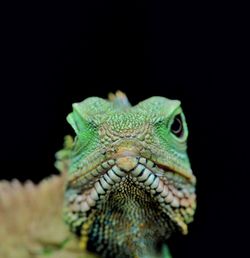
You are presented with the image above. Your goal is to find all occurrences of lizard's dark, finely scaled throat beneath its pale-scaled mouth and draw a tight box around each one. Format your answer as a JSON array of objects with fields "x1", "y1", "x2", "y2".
[{"x1": 85, "y1": 177, "x2": 172, "y2": 258}]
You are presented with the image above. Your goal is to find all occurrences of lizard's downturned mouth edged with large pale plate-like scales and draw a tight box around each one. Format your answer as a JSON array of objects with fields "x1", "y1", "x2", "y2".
[{"x1": 66, "y1": 157, "x2": 196, "y2": 234}]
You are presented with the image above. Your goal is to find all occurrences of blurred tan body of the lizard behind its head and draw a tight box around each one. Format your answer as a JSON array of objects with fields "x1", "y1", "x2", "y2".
[{"x1": 0, "y1": 174, "x2": 97, "y2": 258}]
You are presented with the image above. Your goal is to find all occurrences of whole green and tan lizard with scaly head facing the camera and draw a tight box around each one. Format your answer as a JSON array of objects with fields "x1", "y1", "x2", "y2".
[{"x1": 0, "y1": 91, "x2": 196, "y2": 258}]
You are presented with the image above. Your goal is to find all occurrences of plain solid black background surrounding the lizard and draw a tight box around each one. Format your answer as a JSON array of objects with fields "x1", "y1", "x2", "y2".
[{"x1": 0, "y1": 1, "x2": 249, "y2": 258}]
